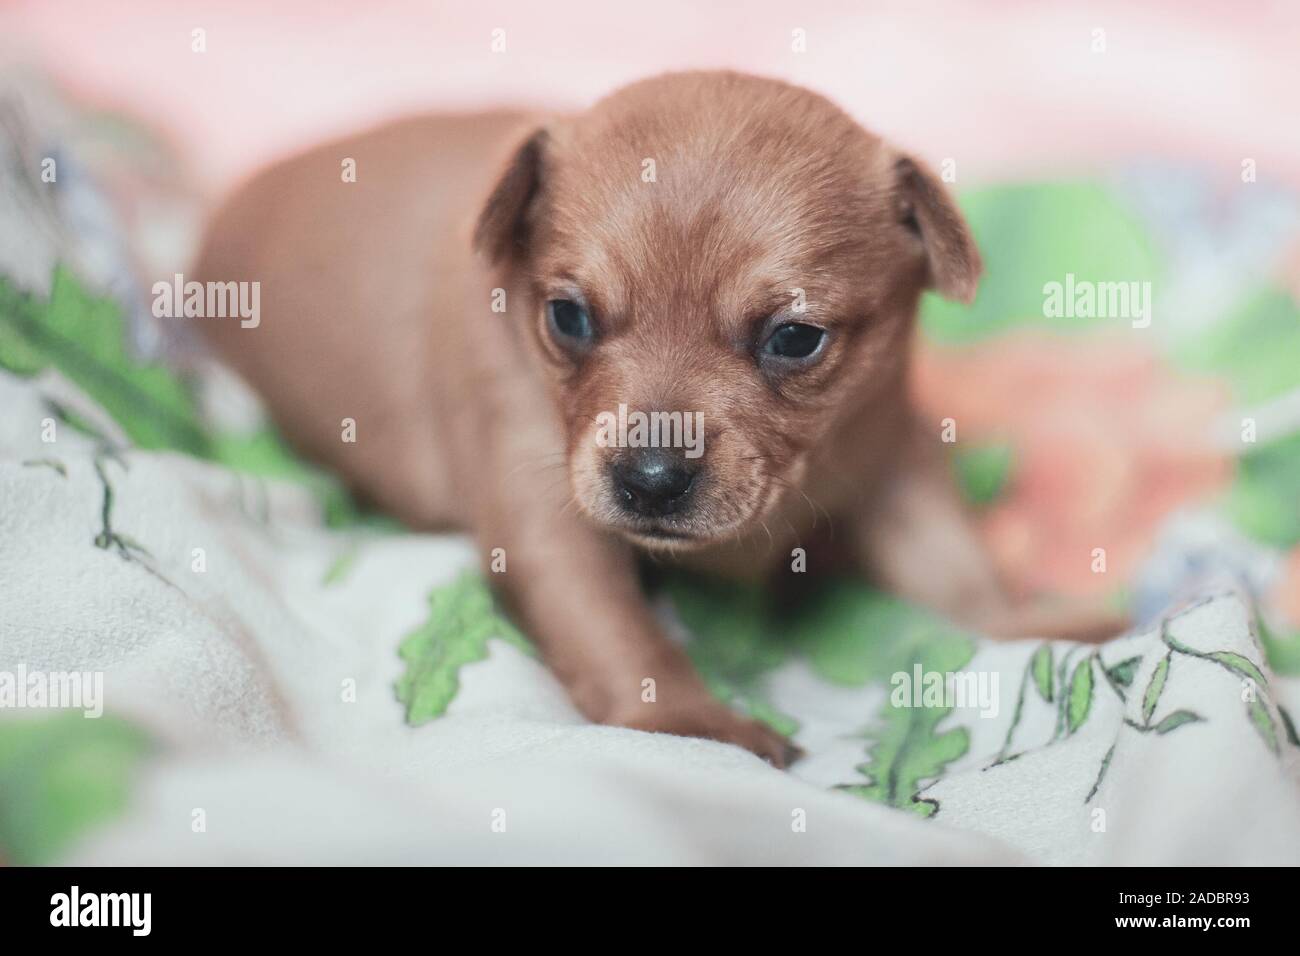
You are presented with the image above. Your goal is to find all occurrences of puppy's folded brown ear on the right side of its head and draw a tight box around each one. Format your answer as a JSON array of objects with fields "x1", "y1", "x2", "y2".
[{"x1": 894, "y1": 156, "x2": 983, "y2": 303}]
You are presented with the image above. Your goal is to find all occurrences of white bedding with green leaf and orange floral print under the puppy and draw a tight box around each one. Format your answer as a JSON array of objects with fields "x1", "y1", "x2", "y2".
[{"x1": 0, "y1": 106, "x2": 1300, "y2": 865}]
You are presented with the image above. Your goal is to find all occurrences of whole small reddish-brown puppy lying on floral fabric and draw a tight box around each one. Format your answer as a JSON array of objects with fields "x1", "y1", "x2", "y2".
[{"x1": 191, "y1": 73, "x2": 1117, "y2": 765}]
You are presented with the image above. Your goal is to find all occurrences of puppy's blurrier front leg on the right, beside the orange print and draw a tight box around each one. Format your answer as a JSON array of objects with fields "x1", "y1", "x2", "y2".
[{"x1": 855, "y1": 429, "x2": 1127, "y2": 641}]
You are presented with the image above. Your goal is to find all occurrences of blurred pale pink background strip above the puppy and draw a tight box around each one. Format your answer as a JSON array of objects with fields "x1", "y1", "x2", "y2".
[{"x1": 0, "y1": 0, "x2": 1300, "y2": 193}]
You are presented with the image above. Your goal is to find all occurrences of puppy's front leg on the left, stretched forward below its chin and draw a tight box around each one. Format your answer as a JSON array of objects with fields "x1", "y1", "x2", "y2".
[{"x1": 480, "y1": 507, "x2": 798, "y2": 767}]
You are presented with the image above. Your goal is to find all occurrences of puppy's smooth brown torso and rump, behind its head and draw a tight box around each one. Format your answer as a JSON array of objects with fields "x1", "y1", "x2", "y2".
[{"x1": 195, "y1": 113, "x2": 529, "y2": 528}]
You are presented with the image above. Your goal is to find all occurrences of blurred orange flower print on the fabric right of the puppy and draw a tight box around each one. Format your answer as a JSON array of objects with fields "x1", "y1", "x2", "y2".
[{"x1": 915, "y1": 332, "x2": 1234, "y2": 596}]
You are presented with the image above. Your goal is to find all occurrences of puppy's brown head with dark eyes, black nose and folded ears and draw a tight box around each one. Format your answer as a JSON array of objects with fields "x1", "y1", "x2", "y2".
[{"x1": 475, "y1": 73, "x2": 980, "y2": 548}]
